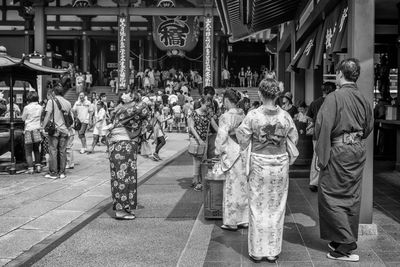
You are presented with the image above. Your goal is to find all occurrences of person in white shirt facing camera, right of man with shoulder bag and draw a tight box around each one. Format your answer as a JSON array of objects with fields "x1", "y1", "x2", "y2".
[{"x1": 72, "y1": 92, "x2": 93, "y2": 154}]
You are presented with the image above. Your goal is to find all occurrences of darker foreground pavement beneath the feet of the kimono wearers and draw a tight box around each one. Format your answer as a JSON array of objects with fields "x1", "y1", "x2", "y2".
[{"x1": 31, "y1": 154, "x2": 400, "y2": 267}]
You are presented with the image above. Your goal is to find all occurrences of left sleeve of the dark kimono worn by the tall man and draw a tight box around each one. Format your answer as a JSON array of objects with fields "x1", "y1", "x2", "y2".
[{"x1": 315, "y1": 93, "x2": 337, "y2": 167}]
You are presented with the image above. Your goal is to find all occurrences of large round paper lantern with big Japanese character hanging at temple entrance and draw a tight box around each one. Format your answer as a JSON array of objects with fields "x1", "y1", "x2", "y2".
[{"x1": 153, "y1": 0, "x2": 200, "y2": 56}]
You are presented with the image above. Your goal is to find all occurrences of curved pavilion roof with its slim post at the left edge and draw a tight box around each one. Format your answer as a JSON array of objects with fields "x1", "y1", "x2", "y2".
[{"x1": 0, "y1": 46, "x2": 67, "y2": 174}]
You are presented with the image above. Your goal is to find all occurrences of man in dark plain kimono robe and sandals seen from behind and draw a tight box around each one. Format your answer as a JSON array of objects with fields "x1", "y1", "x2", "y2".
[{"x1": 315, "y1": 59, "x2": 374, "y2": 261}]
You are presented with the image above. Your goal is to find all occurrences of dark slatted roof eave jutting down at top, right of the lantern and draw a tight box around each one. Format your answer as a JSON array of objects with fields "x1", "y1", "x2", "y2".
[{"x1": 215, "y1": 0, "x2": 302, "y2": 42}]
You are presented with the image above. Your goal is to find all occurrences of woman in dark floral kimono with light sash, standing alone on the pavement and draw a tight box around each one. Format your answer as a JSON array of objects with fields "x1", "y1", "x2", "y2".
[{"x1": 108, "y1": 94, "x2": 150, "y2": 220}]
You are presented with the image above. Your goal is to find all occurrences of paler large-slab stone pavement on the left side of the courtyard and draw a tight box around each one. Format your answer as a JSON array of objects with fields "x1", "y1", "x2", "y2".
[{"x1": 0, "y1": 133, "x2": 188, "y2": 266}]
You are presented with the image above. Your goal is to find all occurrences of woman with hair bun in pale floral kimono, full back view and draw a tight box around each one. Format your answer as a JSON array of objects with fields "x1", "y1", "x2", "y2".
[{"x1": 236, "y1": 79, "x2": 298, "y2": 262}]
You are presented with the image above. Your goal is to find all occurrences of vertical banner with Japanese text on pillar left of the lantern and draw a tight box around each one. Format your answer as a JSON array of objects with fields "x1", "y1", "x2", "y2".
[{"x1": 118, "y1": 14, "x2": 130, "y2": 90}]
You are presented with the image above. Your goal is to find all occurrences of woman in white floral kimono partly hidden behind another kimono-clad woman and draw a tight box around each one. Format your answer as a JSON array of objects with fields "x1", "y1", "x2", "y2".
[{"x1": 215, "y1": 89, "x2": 249, "y2": 231}]
